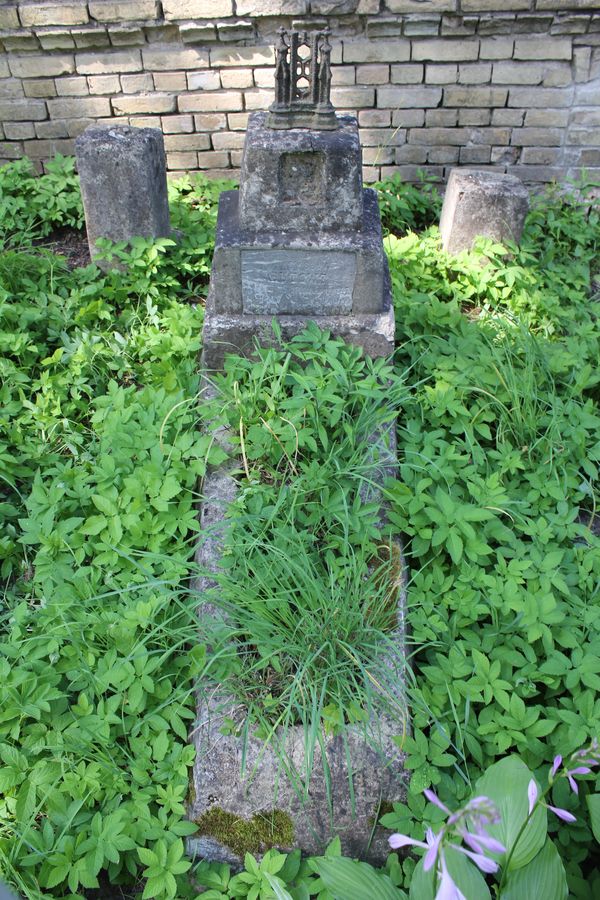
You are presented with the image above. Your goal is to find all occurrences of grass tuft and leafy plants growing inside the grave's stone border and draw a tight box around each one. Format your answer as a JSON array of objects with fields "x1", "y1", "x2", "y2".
[{"x1": 201, "y1": 326, "x2": 404, "y2": 777}]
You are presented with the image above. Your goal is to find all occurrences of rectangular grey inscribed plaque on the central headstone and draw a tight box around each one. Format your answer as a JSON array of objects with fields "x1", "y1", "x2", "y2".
[{"x1": 242, "y1": 249, "x2": 356, "y2": 316}]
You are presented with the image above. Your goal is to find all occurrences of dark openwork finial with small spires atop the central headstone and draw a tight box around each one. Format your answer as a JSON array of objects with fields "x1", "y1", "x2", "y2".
[{"x1": 267, "y1": 27, "x2": 338, "y2": 130}]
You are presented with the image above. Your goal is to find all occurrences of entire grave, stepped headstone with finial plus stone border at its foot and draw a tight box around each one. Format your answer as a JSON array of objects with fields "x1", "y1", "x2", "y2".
[{"x1": 188, "y1": 31, "x2": 407, "y2": 865}]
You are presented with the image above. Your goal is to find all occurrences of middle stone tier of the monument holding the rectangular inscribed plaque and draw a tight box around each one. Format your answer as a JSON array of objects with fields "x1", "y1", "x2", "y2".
[{"x1": 211, "y1": 188, "x2": 387, "y2": 315}]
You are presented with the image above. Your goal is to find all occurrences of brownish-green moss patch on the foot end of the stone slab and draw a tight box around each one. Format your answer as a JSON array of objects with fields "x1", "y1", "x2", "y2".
[{"x1": 195, "y1": 806, "x2": 294, "y2": 858}]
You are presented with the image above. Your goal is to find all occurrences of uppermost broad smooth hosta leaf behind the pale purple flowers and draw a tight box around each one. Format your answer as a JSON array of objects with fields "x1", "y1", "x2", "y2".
[{"x1": 474, "y1": 756, "x2": 548, "y2": 869}]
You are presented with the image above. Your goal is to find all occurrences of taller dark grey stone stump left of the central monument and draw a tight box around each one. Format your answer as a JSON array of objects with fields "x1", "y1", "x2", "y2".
[{"x1": 75, "y1": 125, "x2": 171, "y2": 271}]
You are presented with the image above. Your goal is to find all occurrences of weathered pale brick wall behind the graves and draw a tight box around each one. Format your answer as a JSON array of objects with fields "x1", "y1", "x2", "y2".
[{"x1": 0, "y1": 0, "x2": 600, "y2": 182}]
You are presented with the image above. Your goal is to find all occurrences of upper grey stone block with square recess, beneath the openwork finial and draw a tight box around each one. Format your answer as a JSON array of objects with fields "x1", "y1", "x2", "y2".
[{"x1": 240, "y1": 112, "x2": 363, "y2": 233}]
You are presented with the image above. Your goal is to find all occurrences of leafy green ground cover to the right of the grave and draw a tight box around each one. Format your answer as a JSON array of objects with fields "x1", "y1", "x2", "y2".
[{"x1": 383, "y1": 179, "x2": 600, "y2": 900}]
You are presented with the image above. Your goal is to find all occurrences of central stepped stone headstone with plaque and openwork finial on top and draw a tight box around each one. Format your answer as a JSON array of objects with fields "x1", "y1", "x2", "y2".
[{"x1": 203, "y1": 30, "x2": 394, "y2": 369}]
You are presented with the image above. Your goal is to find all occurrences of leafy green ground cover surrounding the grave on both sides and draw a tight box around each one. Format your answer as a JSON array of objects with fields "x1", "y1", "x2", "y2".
[{"x1": 0, "y1": 160, "x2": 600, "y2": 900}]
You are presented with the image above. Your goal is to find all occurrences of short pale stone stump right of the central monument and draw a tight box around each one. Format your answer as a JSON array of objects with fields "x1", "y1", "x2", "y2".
[{"x1": 440, "y1": 169, "x2": 529, "y2": 253}]
